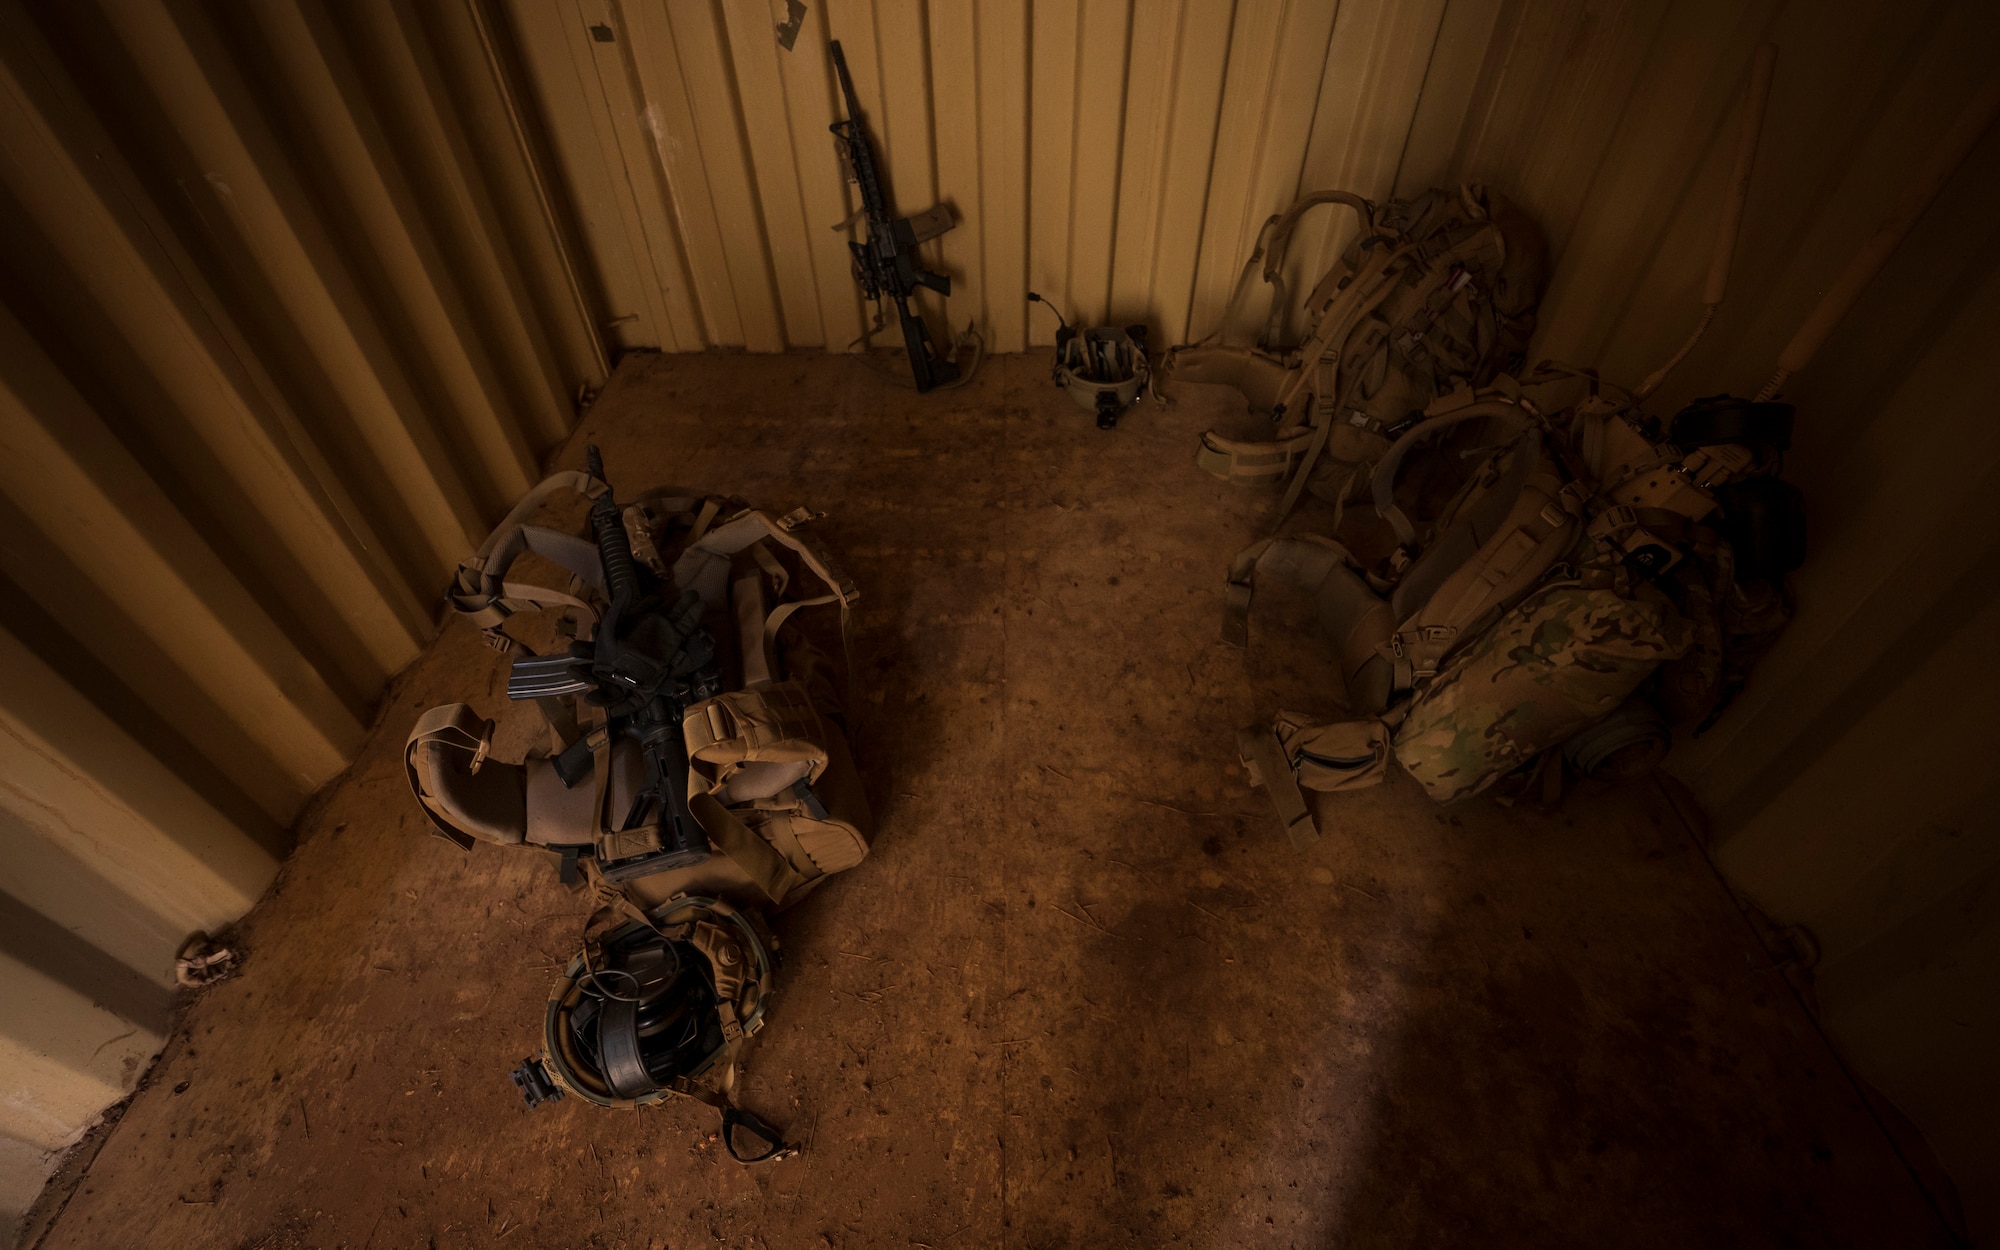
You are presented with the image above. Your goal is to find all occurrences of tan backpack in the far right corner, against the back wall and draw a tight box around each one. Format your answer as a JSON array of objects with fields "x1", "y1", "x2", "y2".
[{"x1": 1156, "y1": 184, "x2": 1548, "y2": 514}]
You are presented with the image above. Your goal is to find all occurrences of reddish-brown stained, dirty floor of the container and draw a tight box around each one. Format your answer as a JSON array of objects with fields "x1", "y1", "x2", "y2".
[{"x1": 27, "y1": 354, "x2": 1938, "y2": 1250}]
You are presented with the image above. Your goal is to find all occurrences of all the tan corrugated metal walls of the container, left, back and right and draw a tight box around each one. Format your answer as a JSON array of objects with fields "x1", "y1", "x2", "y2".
[{"x1": 0, "y1": 0, "x2": 2000, "y2": 1232}]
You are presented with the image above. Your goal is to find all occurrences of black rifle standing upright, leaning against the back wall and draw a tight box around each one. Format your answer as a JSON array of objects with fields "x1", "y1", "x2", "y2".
[{"x1": 828, "y1": 40, "x2": 958, "y2": 390}]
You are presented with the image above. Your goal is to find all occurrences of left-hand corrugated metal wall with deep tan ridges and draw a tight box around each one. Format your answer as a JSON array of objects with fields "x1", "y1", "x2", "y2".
[{"x1": 0, "y1": 0, "x2": 604, "y2": 1210}]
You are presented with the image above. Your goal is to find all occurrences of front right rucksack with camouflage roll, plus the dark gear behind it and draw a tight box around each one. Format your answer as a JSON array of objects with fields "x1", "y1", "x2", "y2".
[{"x1": 1222, "y1": 366, "x2": 1804, "y2": 840}]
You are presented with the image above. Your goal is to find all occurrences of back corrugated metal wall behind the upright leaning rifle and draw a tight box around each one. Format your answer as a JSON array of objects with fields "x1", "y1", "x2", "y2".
[{"x1": 502, "y1": 0, "x2": 1944, "y2": 368}]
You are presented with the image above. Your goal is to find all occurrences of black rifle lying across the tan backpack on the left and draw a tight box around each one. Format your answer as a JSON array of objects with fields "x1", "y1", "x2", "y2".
[{"x1": 506, "y1": 446, "x2": 722, "y2": 882}]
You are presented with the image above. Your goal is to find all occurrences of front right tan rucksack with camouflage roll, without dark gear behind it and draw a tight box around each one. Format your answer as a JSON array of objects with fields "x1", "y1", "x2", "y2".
[{"x1": 1222, "y1": 378, "x2": 1738, "y2": 840}]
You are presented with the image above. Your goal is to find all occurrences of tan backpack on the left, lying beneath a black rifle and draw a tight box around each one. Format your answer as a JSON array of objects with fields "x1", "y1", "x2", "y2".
[{"x1": 404, "y1": 472, "x2": 874, "y2": 908}]
